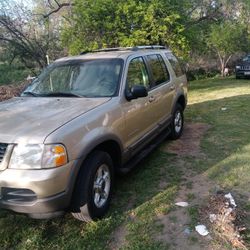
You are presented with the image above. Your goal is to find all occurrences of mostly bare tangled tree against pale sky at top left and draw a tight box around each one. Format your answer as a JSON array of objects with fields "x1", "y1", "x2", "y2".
[{"x1": 0, "y1": 0, "x2": 67, "y2": 68}]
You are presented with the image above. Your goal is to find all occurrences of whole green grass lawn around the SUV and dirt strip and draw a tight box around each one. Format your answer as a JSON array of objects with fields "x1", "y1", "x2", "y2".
[{"x1": 0, "y1": 75, "x2": 250, "y2": 250}]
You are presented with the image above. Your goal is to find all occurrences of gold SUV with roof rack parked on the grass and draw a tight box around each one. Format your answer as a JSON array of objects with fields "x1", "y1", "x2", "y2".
[{"x1": 0, "y1": 46, "x2": 187, "y2": 221}]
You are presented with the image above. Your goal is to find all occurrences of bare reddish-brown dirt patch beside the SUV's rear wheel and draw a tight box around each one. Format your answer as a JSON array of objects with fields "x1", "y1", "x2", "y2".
[{"x1": 164, "y1": 123, "x2": 210, "y2": 157}]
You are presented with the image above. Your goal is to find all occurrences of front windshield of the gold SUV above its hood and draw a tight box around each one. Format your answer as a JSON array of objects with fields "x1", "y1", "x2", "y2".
[{"x1": 22, "y1": 59, "x2": 123, "y2": 97}]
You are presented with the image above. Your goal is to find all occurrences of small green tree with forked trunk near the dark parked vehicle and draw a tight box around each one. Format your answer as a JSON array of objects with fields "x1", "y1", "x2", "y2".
[{"x1": 208, "y1": 21, "x2": 249, "y2": 76}]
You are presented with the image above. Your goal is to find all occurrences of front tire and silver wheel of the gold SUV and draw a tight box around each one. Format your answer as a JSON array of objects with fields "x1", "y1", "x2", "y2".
[{"x1": 72, "y1": 151, "x2": 114, "y2": 222}]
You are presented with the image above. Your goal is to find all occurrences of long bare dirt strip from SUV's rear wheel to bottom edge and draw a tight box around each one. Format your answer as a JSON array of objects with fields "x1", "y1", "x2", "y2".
[{"x1": 157, "y1": 123, "x2": 226, "y2": 250}]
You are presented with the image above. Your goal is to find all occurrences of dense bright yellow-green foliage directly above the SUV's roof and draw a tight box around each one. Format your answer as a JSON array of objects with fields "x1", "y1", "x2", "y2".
[{"x1": 62, "y1": 0, "x2": 188, "y2": 54}]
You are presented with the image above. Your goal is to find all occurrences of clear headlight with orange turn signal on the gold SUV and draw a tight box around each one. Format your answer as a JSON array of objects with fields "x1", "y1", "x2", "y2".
[{"x1": 9, "y1": 144, "x2": 68, "y2": 169}]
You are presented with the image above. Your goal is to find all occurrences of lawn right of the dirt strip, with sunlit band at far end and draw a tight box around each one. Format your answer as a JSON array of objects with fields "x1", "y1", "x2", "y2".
[{"x1": 187, "y1": 79, "x2": 250, "y2": 195}]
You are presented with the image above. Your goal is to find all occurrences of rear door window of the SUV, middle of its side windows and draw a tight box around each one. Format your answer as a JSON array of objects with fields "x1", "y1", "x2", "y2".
[{"x1": 147, "y1": 55, "x2": 170, "y2": 85}]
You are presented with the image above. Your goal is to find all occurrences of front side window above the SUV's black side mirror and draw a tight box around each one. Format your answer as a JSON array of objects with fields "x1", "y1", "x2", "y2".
[{"x1": 127, "y1": 57, "x2": 149, "y2": 88}]
